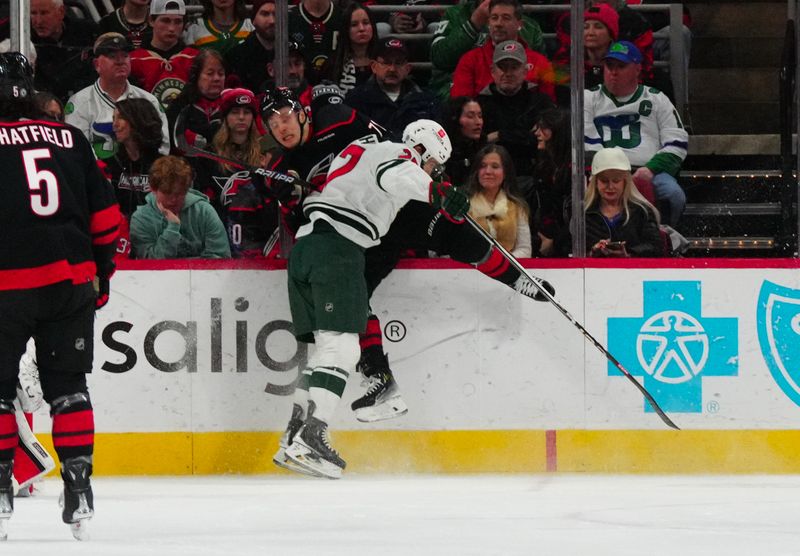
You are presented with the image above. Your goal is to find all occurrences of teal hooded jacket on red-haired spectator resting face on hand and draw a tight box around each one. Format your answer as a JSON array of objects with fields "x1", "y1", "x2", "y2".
[{"x1": 131, "y1": 189, "x2": 231, "y2": 259}]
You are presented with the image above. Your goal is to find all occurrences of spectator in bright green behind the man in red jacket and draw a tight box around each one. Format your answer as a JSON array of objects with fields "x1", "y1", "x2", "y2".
[{"x1": 430, "y1": 0, "x2": 544, "y2": 100}]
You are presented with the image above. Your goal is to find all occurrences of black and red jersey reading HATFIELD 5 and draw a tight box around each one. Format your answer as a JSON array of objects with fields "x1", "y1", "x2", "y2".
[{"x1": 0, "y1": 120, "x2": 120, "y2": 290}]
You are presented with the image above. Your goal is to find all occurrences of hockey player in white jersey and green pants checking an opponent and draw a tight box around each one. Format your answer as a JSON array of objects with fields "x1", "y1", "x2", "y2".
[{"x1": 286, "y1": 120, "x2": 469, "y2": 478}]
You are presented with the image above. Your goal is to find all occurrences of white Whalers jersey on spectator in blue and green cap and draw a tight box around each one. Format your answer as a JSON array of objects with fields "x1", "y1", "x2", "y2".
[{"x1": 583, "y1": 85, "x2": 689, "y2": 175}]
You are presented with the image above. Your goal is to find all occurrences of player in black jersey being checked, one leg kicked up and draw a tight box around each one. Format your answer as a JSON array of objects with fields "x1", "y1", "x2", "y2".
[{"x1": 262, "y1": 85, "x2": 552, "y2": 450}]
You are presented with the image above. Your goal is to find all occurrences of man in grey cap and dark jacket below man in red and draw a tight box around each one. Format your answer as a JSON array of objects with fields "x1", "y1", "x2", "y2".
[{"x1": 478, "y1": 41, "x2": 554, "y2": 193}]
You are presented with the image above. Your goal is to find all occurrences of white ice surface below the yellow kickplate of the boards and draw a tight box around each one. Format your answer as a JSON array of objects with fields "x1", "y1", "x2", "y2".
[{"x1": 6, "y1": 474, "x2": 800, "y2": 556}]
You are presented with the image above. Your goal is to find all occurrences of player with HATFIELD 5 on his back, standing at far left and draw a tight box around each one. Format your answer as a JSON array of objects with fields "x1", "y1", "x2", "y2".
[{"x1": 0, "y1": 53, "x2": 120, "y2": 539}]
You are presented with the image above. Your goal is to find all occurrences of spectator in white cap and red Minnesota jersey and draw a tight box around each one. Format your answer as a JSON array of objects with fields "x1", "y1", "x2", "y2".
[{"x1": 131, "y1": 0, "x2": 200, "y2": 109}]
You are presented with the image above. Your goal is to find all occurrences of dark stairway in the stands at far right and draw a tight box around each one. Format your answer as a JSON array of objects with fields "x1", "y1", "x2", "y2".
[{"x1": 679, "y1": 0, "x2": 797, "y2": 257}]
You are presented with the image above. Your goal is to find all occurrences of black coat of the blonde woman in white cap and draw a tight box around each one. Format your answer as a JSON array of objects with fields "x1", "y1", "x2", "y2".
[{"x1": 586, "y1": 202, "x2": 665, "y2": 257}]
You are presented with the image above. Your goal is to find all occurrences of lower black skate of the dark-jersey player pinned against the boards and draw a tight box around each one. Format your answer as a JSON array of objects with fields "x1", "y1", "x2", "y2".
[{"x1": 350, "y1": 349, "x2": 408, "y2": 423}]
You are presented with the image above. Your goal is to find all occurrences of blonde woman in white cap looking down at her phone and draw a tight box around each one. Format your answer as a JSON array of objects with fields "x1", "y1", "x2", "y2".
[{"x1": 584, "y1": 148, "x2": 665, "y2": 257}]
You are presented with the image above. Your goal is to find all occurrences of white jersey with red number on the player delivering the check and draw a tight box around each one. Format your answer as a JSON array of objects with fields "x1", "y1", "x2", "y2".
[{"x1": 297, "y1": 138, "x2": 431, "y2": 248}]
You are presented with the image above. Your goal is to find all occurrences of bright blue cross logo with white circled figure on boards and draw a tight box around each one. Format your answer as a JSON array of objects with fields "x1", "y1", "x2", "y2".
[{"x1": 608, "y1": 281, "x2": 739, "y2": 413}]
